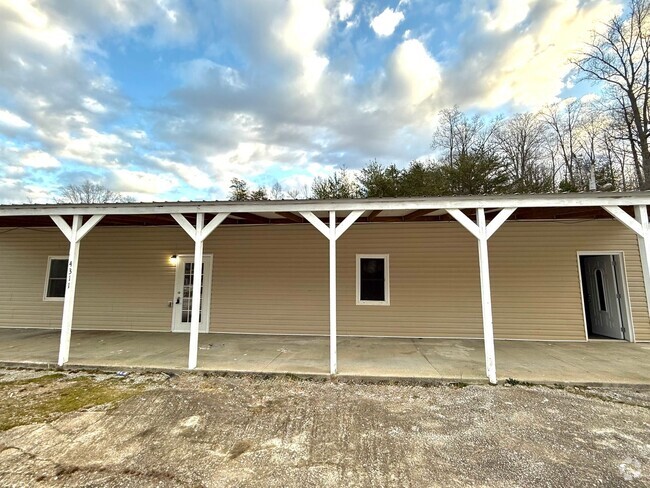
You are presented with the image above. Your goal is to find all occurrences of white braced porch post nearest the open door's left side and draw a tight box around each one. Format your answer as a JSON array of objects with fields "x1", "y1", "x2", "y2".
[{"x1": 447, "y1": 207, "x2": 516, "y2": 385}]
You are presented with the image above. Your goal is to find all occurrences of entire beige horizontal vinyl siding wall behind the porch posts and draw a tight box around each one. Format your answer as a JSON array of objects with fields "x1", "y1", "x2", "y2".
[{"x1": 0, "y1": 221, "x2": 650, "y2": 340}]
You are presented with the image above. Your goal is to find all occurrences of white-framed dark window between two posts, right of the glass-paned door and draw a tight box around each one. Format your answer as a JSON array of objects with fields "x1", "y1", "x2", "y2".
[{"x1": 357, "y1": 254, "x2": 390, "y2": 305}]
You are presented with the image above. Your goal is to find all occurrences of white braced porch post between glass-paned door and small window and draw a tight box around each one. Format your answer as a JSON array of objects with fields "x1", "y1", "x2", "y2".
[{"x1": 300, "y1": 210, "x2": 364, "y2": 375}]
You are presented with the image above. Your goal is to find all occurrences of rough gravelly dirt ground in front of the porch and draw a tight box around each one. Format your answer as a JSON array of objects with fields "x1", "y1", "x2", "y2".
[{"x1": 0, "y1": 370, "x2": 650, "y2": 488}]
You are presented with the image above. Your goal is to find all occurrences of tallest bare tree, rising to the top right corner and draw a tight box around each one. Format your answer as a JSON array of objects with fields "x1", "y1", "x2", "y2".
[{"x1": 575, "y1": 0, "x2": 650, "y2": 190}]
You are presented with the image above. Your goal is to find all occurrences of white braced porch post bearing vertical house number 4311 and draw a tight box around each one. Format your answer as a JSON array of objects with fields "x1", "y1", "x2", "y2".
[{"x1": 52, "y1": 215, "x2": 103, "y2": 366}]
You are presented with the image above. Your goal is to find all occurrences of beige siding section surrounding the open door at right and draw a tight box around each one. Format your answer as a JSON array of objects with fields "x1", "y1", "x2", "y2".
[{"x1": 489, "y1": 221, "x2": 650, "y2": 340}]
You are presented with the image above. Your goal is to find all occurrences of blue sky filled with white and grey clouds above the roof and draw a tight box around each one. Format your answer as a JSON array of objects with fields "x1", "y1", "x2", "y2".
[{"x1": 0, "y1": 0, "x2": 624, "y2": 203}]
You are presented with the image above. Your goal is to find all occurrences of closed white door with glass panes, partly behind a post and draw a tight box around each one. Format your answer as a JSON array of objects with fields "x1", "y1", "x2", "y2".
[{"x1": 172, "y1": 255, "x2": 212, "y2": 332}]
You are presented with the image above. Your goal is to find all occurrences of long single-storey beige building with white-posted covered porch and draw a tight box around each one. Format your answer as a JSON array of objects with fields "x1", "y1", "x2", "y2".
[{"x1": 0, "y1": 192, "x2": 650, "y2": 383}]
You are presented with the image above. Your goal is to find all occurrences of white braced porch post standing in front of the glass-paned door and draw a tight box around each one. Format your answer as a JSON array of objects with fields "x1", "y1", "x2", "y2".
[{"x1": 171, "y1": 212, "x2": 228, "y2": 369}]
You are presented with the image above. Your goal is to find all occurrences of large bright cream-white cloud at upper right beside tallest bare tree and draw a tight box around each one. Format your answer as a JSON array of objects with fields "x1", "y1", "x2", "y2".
[{"x1": 445, "y1": 0, "x2": 620, "y2": 109}]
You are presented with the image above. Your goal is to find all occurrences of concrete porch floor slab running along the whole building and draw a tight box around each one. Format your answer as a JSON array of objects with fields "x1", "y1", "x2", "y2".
[{"x1": 0, "y1": 329, "x2": 650, "y2": 385}]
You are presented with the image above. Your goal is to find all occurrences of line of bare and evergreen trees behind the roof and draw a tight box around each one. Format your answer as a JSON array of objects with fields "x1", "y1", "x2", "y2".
[{"x1": 230, "y1": 0, "x2": 650, "y2": 200}]
